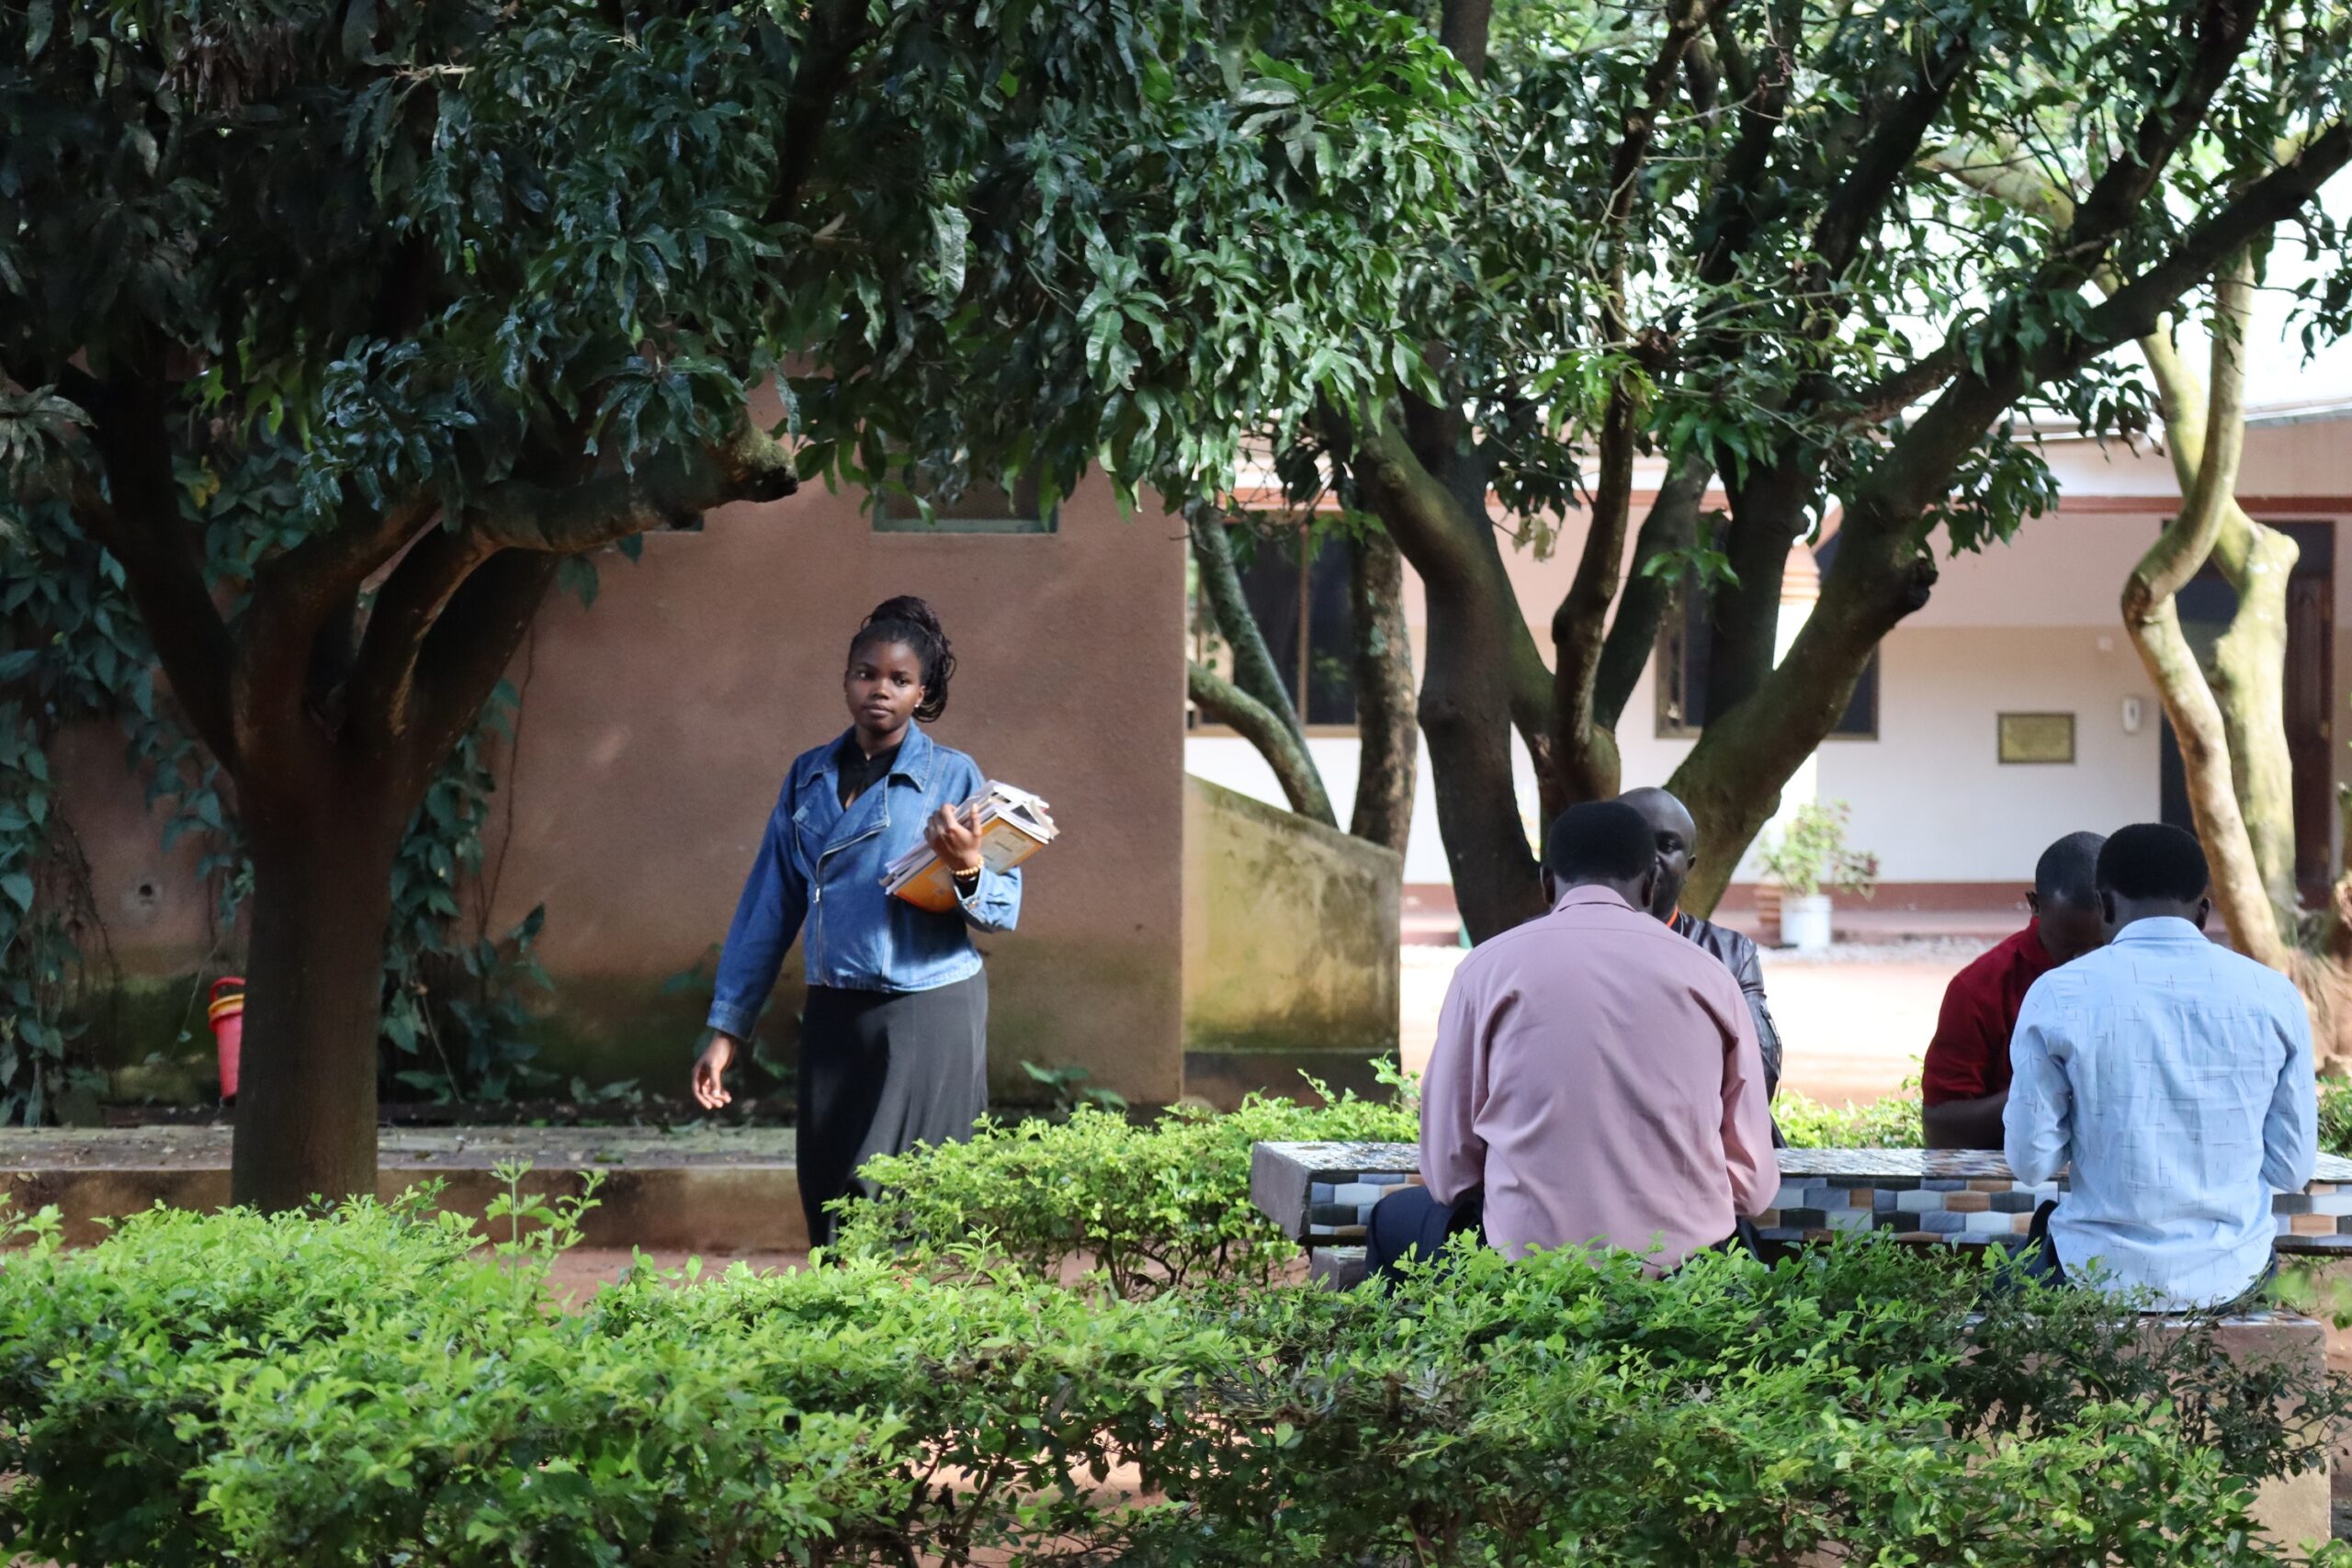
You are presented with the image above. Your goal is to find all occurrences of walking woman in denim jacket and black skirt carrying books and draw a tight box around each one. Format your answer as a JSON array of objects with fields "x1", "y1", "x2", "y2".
[{"x1": 694, "y1": 597, "x2": 1021, "y2": 1246}]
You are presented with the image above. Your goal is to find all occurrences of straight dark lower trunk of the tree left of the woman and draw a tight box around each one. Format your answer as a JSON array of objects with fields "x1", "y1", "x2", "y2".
[{"x1": 228, "y1": 790, "x2": 407, "y2": 1211}]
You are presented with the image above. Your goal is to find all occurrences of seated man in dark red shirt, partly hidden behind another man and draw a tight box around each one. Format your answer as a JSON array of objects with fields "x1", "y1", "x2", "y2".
[{"x1": 1919, "y1": 832, "x2": 2108, "y2": 1149}]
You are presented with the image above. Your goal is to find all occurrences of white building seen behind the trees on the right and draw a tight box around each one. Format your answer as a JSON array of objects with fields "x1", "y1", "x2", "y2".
[{"x1": 1185, "y1": 392, "x2": 2352, "y2": 909}]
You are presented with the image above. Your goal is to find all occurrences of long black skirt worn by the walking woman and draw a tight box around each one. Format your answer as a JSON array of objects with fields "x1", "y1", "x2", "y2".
[{"x1": 797, "y1": 971, "x2": 988, "y2": 1246}]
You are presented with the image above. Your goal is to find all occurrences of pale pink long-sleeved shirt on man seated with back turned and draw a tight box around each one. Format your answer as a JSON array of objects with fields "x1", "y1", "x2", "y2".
[{"x1": 1420, "y1": 886, "x2": 1781, "y2": 1269}]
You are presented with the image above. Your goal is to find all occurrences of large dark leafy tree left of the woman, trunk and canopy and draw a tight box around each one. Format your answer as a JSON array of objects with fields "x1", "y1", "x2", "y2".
[{"x1": 0, "y1": 0, "x2": 1463, "y2": 1201}]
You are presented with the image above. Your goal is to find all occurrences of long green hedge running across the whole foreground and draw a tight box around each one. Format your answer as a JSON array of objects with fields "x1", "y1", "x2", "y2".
[{"x1": 0, "y1": 1203, "x2": 2345, "y2": 1568}]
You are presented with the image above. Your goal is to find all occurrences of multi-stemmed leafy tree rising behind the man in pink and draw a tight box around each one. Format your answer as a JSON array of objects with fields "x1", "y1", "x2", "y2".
[{"x1": 1270, "y1": 0, "x2": 2352, "y2": 933}]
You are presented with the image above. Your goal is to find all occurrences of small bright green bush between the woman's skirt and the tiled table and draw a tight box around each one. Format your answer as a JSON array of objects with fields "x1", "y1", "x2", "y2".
[{"x1": 840, "y1": 1096, "x2": 1419, "y2": 1298}]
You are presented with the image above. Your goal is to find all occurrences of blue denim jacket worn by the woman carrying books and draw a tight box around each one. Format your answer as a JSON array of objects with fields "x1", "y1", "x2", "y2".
[{"x1": 710, "y1": 724, "x2": 1021, "y2": 1039}]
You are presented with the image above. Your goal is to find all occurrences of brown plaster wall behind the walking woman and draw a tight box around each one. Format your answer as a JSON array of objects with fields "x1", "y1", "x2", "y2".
[{"x1": 59, "y1": 479, "x2": 1185, "y2": 1102}]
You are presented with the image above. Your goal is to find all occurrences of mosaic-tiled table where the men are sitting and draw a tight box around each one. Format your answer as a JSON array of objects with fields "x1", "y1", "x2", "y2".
[{"x1": 1249, "y1": 1143, "x2": 2352, "y2": 1253}]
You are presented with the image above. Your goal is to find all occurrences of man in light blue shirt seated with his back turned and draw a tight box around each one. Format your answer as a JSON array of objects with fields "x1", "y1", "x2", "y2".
[{"x1": 2004, "y1": 823, "x2": 2319, "y2": 1309}]
